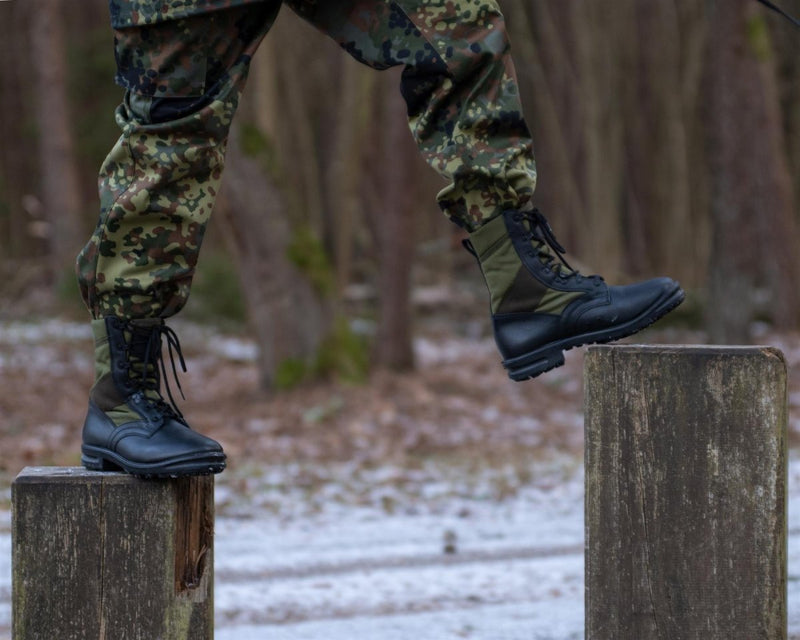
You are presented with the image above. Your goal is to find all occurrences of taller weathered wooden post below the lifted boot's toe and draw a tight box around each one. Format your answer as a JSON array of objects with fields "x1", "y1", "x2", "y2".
[{"x1": 585, "y1": 346, "x2": 787, "y2": 640}]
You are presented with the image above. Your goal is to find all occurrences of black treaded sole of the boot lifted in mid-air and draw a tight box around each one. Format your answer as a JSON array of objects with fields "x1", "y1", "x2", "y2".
[{"x1": 503, "y1": 287, "x2": 686, "y2": 382}]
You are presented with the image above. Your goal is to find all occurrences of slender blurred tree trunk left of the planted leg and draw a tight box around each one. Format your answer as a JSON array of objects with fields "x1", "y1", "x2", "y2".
[{"x1": 27, "y1": 0, "x2": 83, "y2": 282}]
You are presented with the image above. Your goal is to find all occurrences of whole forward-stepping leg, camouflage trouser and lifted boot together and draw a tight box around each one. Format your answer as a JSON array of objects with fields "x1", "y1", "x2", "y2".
[{"x1": 287, "y1": 0, "x2": 683, "y2": 380}]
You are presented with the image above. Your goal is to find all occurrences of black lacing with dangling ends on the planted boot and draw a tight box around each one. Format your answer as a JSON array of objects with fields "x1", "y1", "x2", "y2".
[{"x1": 127, "y1": 323, "x2": 186, "y2": 421}]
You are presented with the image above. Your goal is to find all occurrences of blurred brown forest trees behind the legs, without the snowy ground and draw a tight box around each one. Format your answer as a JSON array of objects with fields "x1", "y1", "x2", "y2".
[{"x1": 0, "y1": 0, "x2": 800, "y2": 388}]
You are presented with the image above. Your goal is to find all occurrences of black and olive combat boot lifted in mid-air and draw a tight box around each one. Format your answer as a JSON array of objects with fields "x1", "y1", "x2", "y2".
[{"x1": 464, "y1": 209, "x2": 684, "y2": 380}]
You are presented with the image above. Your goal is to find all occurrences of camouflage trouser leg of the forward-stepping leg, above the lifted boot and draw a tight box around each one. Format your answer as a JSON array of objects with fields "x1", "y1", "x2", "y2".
[{"x1": 287, "y1": 0, "x2": 536, "y2": 230}]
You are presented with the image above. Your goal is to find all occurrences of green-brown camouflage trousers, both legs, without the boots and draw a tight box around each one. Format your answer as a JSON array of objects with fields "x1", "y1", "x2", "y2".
[{"x1": 77, "y1": 0, "x2": 536, "y2": 318}]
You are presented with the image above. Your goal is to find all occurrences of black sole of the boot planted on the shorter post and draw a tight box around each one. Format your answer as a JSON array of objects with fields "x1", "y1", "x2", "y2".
[{"x1": 81, "y1": 445, "x2": 226, "y2": 478}]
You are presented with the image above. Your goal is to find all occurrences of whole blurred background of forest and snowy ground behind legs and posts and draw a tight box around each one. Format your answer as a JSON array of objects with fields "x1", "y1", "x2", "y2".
[{"x1": 0, "y1": 0, "x2": 800, "y2": 640}]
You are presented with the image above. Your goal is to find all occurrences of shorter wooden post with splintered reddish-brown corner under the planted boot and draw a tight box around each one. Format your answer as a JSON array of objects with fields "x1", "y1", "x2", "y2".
[{"x1": 12, "y1": 467, "x2": 214, "y2": 640}]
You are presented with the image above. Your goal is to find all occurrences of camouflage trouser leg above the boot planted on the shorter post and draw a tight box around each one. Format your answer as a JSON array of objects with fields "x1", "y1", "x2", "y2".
[{"x1": 77, "y1": 0, "x2": 280, "y2": 318}]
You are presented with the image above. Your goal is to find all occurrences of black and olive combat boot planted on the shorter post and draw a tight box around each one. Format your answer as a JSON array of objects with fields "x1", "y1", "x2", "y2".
[{"x1": 81, "y1": 317, "x2": 225, "y2": 478}]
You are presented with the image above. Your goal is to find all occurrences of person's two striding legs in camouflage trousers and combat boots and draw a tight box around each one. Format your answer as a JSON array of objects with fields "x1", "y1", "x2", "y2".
[{"x1": 77, "y1": 0, "x2": 683, "y2": 477}]
